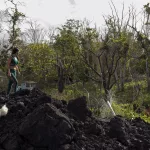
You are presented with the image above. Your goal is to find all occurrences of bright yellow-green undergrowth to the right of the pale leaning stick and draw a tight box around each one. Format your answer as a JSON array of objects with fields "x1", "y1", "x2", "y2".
[{"x1": 112, "y1": 80, "x2": 150, "y2": 123}]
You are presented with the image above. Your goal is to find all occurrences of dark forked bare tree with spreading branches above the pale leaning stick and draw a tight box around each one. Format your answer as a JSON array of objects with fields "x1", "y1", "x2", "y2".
[{"x1": 82, "y1": 32, "x2": 122, "y2": 97}]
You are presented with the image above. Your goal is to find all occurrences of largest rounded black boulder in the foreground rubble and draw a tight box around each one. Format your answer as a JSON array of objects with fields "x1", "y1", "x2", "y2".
[{"x1": 19, "y1": 103, "x2": 74, "y2": 148}]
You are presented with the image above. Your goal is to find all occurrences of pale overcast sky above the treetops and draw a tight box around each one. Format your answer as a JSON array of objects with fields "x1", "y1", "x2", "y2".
[{"x1": 0, "y1": 0, "x2": 150, "y2": 26}]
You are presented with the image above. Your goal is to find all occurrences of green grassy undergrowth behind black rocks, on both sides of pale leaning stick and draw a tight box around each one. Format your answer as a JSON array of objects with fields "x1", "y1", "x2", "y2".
[{"x1": 43, "y1": 80, "x2": 150, "y2": 123}]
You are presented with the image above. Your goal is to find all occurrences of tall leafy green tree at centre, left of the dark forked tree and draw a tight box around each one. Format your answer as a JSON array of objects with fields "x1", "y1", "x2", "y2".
[{"x1": 54, "y1": 20, "x2": 87, "y2": 83}]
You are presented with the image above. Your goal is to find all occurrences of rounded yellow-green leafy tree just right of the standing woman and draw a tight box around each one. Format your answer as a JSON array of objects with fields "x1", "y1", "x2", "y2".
[{"x1": 21, "y1": 44, "x2": 56, "y2": 83}]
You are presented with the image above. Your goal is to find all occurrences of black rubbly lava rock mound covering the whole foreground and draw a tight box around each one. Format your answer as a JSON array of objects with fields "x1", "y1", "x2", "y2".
[{"x1": 0, "y1": 89, "x2": 150, "y2": 150}]
